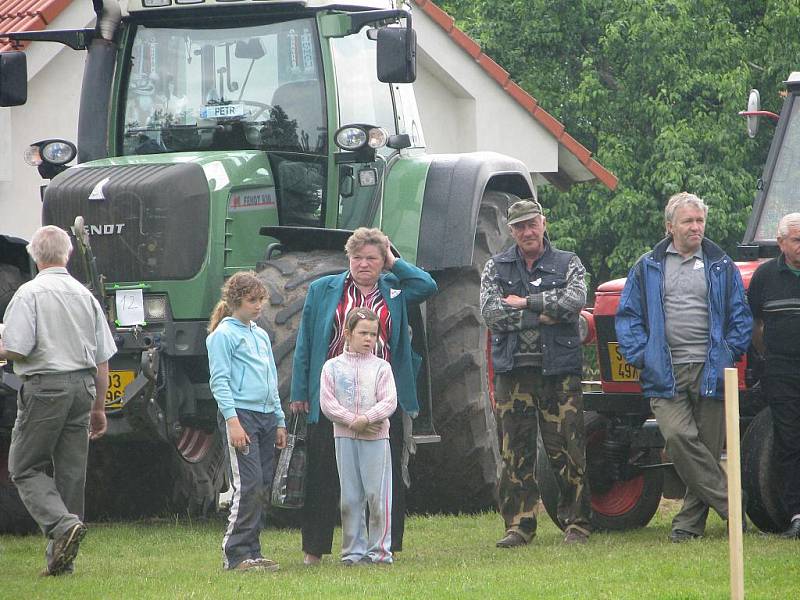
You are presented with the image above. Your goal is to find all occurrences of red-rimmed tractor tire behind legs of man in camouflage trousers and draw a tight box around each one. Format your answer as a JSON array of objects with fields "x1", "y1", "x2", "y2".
[{"x1": 536, "y1": 412, "x2": 664, "y2": 531}]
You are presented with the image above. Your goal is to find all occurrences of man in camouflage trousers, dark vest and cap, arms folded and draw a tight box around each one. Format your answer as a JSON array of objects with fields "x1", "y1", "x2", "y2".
[{"x1": 481, "y1": 200, "x2": 590, "y2": 548}]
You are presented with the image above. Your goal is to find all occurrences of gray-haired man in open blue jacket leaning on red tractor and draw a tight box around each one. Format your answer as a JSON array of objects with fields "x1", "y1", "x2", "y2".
[{"x1": 616, "y1": 192, "x2": 753, "y2": 543}]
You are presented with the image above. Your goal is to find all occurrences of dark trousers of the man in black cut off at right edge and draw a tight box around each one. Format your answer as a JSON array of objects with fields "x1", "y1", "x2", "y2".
[{"x1": 764, "y1": 375, "x2": 800, "y2": 517}]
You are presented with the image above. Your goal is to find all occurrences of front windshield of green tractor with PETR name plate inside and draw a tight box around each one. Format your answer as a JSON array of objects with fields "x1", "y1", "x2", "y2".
[{"x1": 121, "y1": 19, "x2": 327, "y2": 155}]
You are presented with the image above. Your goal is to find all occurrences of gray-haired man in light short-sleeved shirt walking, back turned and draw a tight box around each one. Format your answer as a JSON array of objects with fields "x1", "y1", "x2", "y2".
[{"x1": 0, "y1": 225, "x2": 116, "y2": 575}]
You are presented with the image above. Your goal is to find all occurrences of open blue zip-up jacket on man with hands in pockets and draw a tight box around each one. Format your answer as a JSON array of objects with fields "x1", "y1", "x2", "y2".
[{"x1": 615, "y1": 237, "x2": 753, "y2": 398}]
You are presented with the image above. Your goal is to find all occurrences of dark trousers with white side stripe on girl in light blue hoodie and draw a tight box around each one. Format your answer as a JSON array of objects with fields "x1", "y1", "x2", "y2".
[{"x1": 217, "y1": 409, "x2": 278, "y2": 569}]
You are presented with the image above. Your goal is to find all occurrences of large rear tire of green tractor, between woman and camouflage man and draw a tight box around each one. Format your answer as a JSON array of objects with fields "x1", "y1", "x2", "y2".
[{"x1": 409, "y1": 191, "x2": 518, "y2": 513}]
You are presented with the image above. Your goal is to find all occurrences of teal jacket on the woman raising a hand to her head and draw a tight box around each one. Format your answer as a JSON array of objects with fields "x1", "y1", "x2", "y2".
[{"x1": 292, "y1": 258, "x2": 438, "y2": 423}]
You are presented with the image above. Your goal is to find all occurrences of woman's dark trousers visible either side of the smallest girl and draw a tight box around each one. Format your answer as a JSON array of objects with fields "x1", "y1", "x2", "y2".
[{"x1": 302, "y1": 409, "x2": 406, "y2": 556}]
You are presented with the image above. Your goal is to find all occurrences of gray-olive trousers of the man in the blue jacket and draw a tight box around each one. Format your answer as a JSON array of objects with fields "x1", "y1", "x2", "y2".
[{"x1": 650, "y1": 363, "x2": 728, "y2": 535}]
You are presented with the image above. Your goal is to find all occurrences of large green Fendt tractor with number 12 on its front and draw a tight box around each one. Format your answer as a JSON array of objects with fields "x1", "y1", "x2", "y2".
[{"x1": 0, "y1": 0, "x2": 535, "y2": 528}]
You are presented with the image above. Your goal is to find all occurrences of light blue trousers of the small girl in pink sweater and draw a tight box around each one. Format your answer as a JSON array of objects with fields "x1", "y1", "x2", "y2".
[{"x1": 336, "y1": 437, "x2": 392, "y2": 563}]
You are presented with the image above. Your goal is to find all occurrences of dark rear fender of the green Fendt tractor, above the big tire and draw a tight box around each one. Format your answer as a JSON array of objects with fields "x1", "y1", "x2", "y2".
[{"x1": 417, "y1": 152, "x2": 536, "y2": 271}]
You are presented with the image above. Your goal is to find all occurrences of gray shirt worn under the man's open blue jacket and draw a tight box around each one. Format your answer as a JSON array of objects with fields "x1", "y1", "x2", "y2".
[{"x1": 664, "y1": 244, "x2": 708, "y2": 364}]
